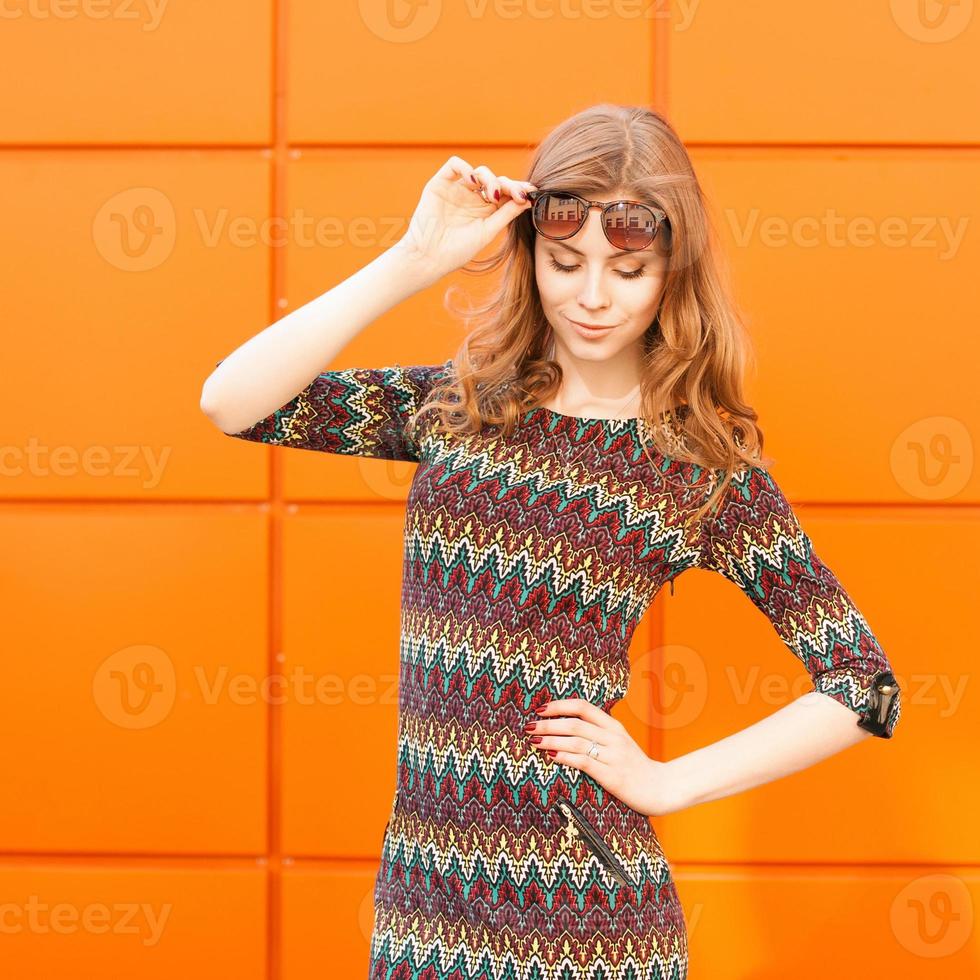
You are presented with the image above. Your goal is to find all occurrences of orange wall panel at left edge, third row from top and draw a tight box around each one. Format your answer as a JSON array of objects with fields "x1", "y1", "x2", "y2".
[{"x1": 0, "y1": 505, "x2": 268, "y2": 854}]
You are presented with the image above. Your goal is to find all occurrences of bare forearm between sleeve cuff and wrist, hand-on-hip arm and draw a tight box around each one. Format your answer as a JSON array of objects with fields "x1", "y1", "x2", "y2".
[{"x1": 664, "y1": 691, "x2": 874, "y2": 813}]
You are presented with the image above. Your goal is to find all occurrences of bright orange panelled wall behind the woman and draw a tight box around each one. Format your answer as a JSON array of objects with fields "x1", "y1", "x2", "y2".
[{"x1": 0, "y1": 0, "x2": 980, "y2": 980}]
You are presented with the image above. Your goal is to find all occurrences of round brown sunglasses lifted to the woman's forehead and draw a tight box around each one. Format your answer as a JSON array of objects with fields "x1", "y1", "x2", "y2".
[{"x1": 527, "y1": 191, "x2": 670, "y2": 252}]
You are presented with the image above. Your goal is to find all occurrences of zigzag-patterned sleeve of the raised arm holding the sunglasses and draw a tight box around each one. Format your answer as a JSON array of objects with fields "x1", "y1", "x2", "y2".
[{"x1": 218, "y1": 360, "x2": 451, "y2": 462}]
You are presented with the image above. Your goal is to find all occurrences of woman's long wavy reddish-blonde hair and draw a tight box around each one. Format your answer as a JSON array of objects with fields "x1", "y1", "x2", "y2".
[{"x1": 411, "y1": 103, "x2": 763, "y2": 518}]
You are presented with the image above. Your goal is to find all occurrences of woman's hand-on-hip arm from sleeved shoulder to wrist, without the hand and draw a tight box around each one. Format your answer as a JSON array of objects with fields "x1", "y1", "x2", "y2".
[{"x1": 663, "y1": 467, "x2": 901, "y2": 808}]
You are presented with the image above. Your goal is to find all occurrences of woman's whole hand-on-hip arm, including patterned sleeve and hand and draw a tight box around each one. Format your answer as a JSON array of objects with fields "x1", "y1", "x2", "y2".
[{"x1": 534, "y1": 466, "x2": 902, "y2": 816}]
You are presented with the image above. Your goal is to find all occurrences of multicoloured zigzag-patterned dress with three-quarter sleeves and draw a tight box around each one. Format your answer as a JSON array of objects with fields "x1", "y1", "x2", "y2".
[{"x1": 224, "y1": 361, "x2": 900, "y2": 980}]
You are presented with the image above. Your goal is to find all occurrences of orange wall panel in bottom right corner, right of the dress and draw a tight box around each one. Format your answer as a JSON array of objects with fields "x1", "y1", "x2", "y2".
[{"x1": 677, "y1": 866, "x2": 980, "y2": 980}]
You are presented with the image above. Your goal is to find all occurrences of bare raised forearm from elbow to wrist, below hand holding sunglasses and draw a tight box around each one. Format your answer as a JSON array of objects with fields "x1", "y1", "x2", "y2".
[{"x1": 201, "y1": 245, "x2": 432, "y2": 432}]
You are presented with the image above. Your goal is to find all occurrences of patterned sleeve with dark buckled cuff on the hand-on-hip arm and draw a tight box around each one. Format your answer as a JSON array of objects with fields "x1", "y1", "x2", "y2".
[{"x1": 699, "y1": 466, "x2": 901, "y2": 738}]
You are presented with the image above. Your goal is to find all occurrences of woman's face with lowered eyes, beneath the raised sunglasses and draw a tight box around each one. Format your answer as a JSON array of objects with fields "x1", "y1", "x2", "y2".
[{"x1": 534, "y1": 193, "x2": 667, "y2": 361}]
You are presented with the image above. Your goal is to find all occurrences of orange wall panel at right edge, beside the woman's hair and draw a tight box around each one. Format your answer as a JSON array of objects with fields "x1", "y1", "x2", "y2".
[{"x1": 695, "y1": 150, "x2": 980, "y2": 503}]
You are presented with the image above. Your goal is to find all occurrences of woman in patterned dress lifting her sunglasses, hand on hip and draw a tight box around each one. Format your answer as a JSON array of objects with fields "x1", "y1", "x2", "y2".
[{"x1": 202, "y1": 105, "x2": 900, "y2": 980}]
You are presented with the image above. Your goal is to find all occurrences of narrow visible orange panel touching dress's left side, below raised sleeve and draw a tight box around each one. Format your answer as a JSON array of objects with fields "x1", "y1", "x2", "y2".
[{"x1": 282, "y1": 506, "x2": 404, "y2": 856}]
